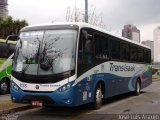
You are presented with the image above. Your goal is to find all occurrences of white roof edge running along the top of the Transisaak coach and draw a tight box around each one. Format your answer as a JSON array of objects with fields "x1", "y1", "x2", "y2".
[{"x1": 21, "y1": 22, "x2": 150, "y2": 49}]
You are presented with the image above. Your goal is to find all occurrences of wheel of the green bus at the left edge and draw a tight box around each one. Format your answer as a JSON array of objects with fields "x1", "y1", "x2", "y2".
[{"x1": 0, "y1": 78, "x2": 10, "y2": 95}]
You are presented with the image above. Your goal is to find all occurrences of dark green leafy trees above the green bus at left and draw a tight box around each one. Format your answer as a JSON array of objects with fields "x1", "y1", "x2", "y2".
[{"x1": 0, "y1": 16, "x2": 28, "y2": 39}]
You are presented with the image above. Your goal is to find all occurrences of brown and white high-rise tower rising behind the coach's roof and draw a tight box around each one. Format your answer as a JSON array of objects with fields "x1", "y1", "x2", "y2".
[{"x1": 122, "y1": 25, "x2": 140, "y2": 43}]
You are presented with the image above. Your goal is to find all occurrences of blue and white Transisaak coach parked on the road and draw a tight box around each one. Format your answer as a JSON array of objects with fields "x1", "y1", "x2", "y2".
[{"x1": 11, "y1": 23, "x2": 152, "y2": 108}]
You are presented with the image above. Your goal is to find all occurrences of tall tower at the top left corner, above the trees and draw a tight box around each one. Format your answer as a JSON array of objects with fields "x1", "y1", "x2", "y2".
[{"x1": 0, "y1": 0, "x2": 8, "y2": 18}]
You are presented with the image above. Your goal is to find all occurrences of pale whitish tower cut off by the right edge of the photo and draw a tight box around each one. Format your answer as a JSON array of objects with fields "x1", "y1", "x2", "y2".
[{"x1": 153, "y1": 26, "x2": 160, "y2": 63}]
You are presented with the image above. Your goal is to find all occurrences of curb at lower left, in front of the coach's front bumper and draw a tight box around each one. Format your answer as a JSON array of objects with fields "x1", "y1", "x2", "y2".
[{"x1": 0, "y1": 105, "x2": 33, "y2": 116}]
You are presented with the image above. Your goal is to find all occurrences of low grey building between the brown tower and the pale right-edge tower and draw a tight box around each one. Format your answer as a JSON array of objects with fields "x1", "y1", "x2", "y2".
[{"x1": 142, "y1": 40, "x2": 154, "y2": 61}]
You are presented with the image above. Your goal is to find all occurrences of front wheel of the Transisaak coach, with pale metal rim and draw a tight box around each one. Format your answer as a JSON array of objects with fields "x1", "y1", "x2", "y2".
[{"x1": 93, "y1": 85, "x2": 103, "y2": 109}]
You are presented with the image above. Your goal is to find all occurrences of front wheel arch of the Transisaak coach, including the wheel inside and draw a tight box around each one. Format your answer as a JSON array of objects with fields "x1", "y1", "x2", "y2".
[{"x1": 92, "y1": 80, "x2": 105, "y2": 109}]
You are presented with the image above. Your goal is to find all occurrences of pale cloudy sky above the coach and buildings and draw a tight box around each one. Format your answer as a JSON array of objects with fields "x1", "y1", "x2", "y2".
[{"x1": 8, "y1": 0, "x2": 160, "y2": 41}]
